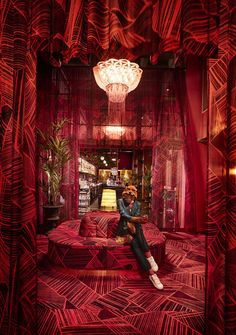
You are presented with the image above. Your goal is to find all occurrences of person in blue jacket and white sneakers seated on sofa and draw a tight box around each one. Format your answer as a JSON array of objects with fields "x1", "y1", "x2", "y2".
[{"x1": 116, "y1": 185, "x2": 163, "y2": 290}]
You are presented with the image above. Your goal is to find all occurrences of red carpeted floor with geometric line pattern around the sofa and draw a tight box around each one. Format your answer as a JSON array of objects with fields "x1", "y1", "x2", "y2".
[{"x1": 38, "y1": 233, "x2": 205, "y2": 335}]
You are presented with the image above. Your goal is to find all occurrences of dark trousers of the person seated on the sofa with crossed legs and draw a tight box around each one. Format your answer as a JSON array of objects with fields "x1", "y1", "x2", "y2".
[{"x1": 130, "y1": 223, "x2": 151, "y2": 271}]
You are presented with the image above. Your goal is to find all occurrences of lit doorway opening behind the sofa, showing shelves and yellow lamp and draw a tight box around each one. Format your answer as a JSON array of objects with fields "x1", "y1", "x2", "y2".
[{"x1": 79, "y1": 148, "x2": 152, "y2": 217}]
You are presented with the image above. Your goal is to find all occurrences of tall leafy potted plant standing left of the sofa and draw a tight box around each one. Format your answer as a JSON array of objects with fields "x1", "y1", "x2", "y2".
[{"x1": 38, "y1": 118, "x2": 72, "y2": 231}]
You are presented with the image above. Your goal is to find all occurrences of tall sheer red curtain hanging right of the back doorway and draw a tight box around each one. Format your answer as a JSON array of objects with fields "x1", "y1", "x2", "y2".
[{"x1": 152, "y1": 62, "x2": 206, "y2": 232}]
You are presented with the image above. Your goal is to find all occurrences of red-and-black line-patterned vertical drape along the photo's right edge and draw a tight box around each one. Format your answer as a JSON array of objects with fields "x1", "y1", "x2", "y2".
[{"x1": 206, "y1": 1, "x2": 236, "y2": 335}]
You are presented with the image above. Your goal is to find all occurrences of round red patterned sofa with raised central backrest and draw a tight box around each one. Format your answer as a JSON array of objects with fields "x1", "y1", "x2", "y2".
[{"x1": 48, "y1": 211, "x2": 165, "y2": 269}]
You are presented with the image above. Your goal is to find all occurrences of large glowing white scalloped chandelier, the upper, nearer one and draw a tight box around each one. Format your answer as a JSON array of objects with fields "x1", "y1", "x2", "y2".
[{"x1": 93, "y1": 58, "x2": 143, "y2": 103}]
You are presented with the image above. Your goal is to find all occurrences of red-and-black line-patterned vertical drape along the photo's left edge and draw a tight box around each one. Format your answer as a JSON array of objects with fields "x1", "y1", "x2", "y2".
[{"x1": 0, "y1": 1, "x2": 36, "y2": 334}]
